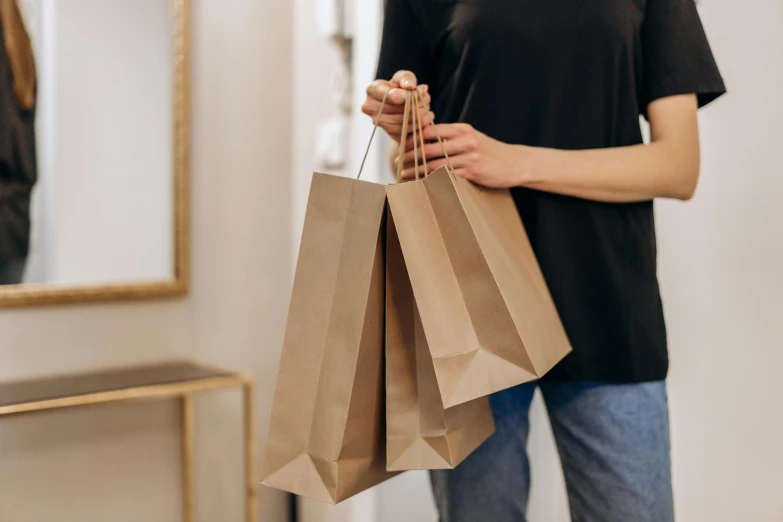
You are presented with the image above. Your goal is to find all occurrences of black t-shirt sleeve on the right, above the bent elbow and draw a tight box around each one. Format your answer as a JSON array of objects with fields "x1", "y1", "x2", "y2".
[{"x1": 641, "y1": 0, "x2": 726, "y2": 108}]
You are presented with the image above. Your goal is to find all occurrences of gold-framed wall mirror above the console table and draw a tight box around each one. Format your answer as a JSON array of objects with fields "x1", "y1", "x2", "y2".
[{"x1": 0, "y1": 0, "x2": 189, "y2": 306}]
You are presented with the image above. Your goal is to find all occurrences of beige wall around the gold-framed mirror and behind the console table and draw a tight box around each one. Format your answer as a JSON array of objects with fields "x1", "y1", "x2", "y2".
[{"x1": 0, "y1": 0, "x2": 292, "y2": 522}]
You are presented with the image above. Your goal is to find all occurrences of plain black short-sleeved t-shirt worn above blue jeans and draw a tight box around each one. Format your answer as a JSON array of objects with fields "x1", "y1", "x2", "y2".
[{"x1": 378, "y1": 0, "x2": 725, "y2": 382}]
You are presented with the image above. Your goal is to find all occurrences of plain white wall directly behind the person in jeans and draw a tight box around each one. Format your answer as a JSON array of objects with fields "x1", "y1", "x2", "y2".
[{"x1": 378, "y1": 0, "x2": 783, "y2": 522}]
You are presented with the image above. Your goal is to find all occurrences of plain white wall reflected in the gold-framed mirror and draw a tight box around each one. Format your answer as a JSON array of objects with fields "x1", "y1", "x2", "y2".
[{"x1": 51, "y1": 0, "x2": 174, "y2": 283}]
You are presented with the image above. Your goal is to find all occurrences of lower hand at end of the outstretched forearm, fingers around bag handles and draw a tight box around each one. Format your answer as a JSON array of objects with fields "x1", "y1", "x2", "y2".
[{"x1": 395, "y1": 123, "x2": 528, "y2": 188}]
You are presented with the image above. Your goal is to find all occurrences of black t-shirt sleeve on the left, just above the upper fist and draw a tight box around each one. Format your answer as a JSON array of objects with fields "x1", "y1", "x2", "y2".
[{"x1": 376, "y1": 0, "x2": 429, "y2": 83}]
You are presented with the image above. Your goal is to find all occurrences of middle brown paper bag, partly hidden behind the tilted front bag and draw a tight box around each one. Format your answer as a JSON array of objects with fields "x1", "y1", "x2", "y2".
[{"x1": 386, "y1": 208, "x2": 495, "y2": 471}]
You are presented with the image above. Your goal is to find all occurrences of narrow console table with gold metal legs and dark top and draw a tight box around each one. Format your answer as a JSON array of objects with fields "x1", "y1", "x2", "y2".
[{"x1": 0, "y1": 361, "x2": 256, "y2": 522}]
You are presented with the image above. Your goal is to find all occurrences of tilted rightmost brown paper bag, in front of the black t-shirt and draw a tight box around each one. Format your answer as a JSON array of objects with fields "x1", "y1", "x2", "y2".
[{"x1": 386, "y1": 167, "x2": 571, "y2": 408}]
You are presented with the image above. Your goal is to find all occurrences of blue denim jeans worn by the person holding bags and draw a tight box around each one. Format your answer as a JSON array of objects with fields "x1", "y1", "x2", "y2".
[{"x1": 430, "y1": 381, "x2": 674, "y2": 522}]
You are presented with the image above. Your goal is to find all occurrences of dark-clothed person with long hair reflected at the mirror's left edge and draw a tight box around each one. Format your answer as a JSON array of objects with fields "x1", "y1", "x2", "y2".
[{"x1": 0, "y1": 0, "x2": 37, "y2": 285}]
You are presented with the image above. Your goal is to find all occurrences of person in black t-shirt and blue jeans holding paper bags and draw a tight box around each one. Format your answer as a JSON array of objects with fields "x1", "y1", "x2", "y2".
[{"x1": 363, "y1": 0, "x2": 725, "y2": 522}]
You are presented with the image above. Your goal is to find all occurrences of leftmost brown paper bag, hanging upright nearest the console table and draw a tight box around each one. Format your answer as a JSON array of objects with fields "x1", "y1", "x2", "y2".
[{"x1": 261, "y1": 174, "x2": 393, "y2": 503}]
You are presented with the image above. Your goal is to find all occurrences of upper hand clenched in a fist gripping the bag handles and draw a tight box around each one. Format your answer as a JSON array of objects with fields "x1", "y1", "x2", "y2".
[{"x1": 362, "y1": 71, "x2": 433, "y2": 143}]
